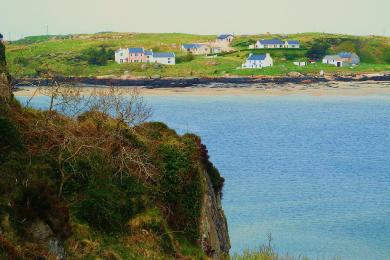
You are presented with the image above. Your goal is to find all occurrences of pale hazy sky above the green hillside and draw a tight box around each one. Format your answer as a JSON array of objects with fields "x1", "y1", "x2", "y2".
[{"x1": 0, "y1": 0, "x2": 390, "y2": 39}]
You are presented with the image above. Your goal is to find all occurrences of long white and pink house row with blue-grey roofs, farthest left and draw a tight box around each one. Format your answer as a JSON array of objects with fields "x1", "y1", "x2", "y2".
[{"x1": 115, "y1": 48, "x2": 176, "y2": 65}]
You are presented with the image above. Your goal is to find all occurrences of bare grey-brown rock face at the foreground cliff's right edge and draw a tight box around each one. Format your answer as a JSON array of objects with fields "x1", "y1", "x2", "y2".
[{"x1": 200, "y1": 172, "x2": 230, "y2": 259}]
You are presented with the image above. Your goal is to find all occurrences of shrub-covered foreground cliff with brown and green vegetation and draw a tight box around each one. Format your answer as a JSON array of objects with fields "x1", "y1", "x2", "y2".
[{"x1": 0, "y1": 44, "x2": 230, "y2": 259}]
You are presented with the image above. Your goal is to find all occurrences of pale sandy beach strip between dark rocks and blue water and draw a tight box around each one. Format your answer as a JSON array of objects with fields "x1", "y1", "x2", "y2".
[{"x1": 14, "y1": 81, "x2": 390, "y2": 97}]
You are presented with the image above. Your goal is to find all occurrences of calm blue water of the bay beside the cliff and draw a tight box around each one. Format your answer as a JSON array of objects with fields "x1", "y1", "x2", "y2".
[{"x1": 16, "y1": 93, "x2": 390, "y2": 259}]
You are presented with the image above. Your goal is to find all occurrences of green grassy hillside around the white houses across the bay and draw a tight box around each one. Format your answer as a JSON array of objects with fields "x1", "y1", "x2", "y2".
[{"x1": 7, "y1": 33, "x2": 390, "y2": 78}]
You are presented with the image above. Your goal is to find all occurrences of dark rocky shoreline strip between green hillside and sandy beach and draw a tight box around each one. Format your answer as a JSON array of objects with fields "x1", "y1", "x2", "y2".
[{"x1": 13, "y1": 72, "x2": 390, "y2": 89}]
